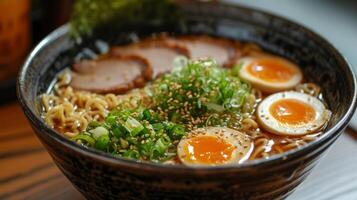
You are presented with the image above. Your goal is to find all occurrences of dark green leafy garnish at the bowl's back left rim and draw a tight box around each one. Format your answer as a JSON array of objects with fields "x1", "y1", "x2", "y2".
[{"x1": 70, "y1": 0, "x2": 178, "y2": 38}]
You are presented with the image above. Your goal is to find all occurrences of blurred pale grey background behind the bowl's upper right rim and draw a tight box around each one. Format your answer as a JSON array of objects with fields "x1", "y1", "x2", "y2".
[{"x1": 224, "y1": 0, "x2": 357, "y2": 130}]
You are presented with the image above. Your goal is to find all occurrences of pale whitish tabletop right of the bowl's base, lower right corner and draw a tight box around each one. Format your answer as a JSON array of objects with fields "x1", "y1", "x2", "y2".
[{"x1": 288, "y1": 133, "x2": 357, "y2": 200}]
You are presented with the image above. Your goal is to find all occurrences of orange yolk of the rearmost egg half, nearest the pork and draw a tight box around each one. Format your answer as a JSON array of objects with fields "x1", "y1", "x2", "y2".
[{"x1": 247, "y1": 58, "x2": 296, "y2": 82}]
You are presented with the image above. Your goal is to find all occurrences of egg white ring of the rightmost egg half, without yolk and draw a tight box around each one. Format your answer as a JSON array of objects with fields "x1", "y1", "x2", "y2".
[{"x1": 256, "y1": 91, "x2": 331, "y2": 136}]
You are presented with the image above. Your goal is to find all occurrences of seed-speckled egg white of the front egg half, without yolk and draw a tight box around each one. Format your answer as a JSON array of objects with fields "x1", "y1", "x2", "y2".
[{"x1": 177, "y1": 127, "x2": 253, "y2": 166}]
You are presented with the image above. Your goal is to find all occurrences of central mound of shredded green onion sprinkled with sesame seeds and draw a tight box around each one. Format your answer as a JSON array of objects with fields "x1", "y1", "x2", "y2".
[{"x1": 152, "y1": 59, "x2": 250, "y2": 129}]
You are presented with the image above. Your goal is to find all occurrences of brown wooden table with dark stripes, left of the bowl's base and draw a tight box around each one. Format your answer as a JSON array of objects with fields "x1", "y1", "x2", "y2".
[{"x1": 0, "y1": 103, "x2": 83, "y2": 200}]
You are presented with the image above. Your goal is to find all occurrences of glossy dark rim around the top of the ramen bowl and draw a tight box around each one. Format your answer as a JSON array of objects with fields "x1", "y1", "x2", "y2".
[{"x1": 17, "y1": 2, "x2": 357, "y2": 174}]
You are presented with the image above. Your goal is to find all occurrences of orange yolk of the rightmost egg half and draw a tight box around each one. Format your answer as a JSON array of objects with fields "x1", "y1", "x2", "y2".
[{"x1": 269, "y1": 99, "x2": 316, "y2": 125}]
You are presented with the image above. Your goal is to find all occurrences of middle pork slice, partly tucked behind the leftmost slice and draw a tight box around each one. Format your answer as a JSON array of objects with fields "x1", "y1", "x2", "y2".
[{"x1": 110, "y1": 40, "x2": 189, "y2": 78}]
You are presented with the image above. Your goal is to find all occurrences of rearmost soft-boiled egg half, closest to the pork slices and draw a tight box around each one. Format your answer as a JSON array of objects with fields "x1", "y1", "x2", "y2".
[{"x1": 239, "y1": 55, "x2": 302, "y2": 93}]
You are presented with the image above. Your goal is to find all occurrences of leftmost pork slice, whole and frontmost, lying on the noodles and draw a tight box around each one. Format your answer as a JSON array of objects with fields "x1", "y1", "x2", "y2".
[{"x1": 70, "y1": 56, "x2": 151, "y2": 94}]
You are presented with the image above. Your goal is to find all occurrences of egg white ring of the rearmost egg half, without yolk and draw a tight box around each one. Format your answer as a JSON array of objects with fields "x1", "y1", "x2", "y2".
[{"x1": 239, "y1": 55, "x2": 303, "y2": 93}]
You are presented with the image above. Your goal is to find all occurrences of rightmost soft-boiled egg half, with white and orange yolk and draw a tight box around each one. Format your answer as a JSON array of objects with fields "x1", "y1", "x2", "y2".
[{"x1": 256, "y1": 91, "x2": 331, "y2": 136}]
